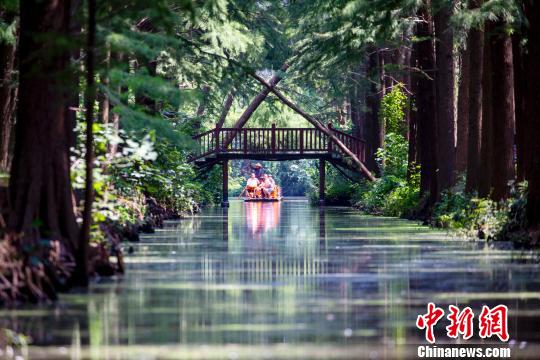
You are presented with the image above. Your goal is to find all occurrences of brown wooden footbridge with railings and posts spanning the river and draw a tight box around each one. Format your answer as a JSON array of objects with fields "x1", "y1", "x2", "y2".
[{"x1": 190, "y1": 124, "x2": 367, "y2": 206}]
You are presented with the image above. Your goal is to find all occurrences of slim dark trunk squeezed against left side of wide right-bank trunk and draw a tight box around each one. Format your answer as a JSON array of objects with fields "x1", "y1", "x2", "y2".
[{"x1": 478, "y1": 22, "x2": 493, "y2": 197}]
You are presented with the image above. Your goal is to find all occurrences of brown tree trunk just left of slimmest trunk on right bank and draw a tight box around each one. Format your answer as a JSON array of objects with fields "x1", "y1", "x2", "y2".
[{"x1": 465, "y1": 6, "x2": 484, "y2": 193}]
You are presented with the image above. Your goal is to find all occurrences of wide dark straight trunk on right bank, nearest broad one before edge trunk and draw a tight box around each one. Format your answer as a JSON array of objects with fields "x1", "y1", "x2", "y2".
[{"x1": 491, "y1": 22, "x2": 515, "y2": 201}]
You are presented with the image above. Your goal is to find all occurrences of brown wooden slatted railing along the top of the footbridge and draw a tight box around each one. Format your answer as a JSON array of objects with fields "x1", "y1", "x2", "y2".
[{"x1": 192, "y1": 125, "x2": 365, "y2": 161}]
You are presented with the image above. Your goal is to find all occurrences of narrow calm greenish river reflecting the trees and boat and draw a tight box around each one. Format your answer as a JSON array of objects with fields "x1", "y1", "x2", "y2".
[{"x1": 0, "y1": 200, "x2": 540, "y2": 359}]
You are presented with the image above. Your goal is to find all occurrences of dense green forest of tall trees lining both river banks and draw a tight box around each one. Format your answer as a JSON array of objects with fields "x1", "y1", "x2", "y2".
[{"x1": 0, "y1": 0, "x2": 540, "y2": 302}]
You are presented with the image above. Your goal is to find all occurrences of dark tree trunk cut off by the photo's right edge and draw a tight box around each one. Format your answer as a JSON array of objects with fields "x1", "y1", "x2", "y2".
[{"x1": 524, "y1": 0, "x2": 540, "y2": 230}]
